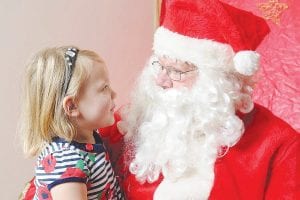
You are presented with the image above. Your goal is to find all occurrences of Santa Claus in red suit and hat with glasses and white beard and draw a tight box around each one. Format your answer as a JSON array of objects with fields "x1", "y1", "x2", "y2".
[{"x1": 112, "y1": 0, "x2": 299, "y2": 200}]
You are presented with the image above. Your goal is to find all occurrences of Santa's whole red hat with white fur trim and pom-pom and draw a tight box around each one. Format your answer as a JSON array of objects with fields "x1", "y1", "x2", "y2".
[{"x1": 153, "y1": 0, "x2": 270, "y2": 75}]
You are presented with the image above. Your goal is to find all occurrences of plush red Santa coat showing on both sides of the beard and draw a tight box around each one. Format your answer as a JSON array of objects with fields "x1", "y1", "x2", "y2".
[{"x1": 123, "y1": 105, "x2": 300, "y2": 200}]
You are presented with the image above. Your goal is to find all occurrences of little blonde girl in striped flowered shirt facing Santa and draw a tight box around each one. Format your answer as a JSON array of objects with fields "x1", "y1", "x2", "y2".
[{"x1": 21, "y1": 47, "x2": 124, "y2": 200}]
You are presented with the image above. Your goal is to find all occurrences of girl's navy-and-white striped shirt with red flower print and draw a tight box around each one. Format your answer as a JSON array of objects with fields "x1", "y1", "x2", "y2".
[{"x1": 34, "y1": 133, "x2": 124, "y2": 200}]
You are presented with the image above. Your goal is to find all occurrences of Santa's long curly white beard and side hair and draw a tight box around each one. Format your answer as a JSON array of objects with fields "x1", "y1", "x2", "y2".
[{"x1": 122, "y1": 60, "x2": 250, "y2": 199}]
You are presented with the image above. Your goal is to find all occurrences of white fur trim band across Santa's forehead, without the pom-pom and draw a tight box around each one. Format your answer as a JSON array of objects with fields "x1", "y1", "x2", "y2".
[{"x1": 153, "y1": 26, "x2": 234, "y2": 71}]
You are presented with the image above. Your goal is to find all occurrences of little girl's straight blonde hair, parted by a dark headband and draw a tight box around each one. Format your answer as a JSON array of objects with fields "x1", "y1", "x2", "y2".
[{"x1": 20, "y1": 46, "x2": 103, "y2": 156}]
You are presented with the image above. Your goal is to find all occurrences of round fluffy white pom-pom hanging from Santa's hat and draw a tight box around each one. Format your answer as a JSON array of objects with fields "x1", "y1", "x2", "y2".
[{"x1": 233, "y1": 51, "x2": 259, "y2": 76}]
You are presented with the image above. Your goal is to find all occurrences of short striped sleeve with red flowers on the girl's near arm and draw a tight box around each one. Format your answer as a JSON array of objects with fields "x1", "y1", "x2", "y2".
[{"x1": 35, "y1": 139, "x2": 90, "y2": 193}]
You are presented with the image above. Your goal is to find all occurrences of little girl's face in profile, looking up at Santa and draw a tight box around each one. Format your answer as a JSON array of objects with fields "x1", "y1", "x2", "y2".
[{"x1": 77, "y1": 62, "x2": 116, "y2": 130}]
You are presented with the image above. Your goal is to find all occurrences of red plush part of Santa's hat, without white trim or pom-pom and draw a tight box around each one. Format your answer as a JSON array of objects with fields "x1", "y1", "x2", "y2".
[{"x1": 160, "y1": 0, "x2": 269, "y2": 51}]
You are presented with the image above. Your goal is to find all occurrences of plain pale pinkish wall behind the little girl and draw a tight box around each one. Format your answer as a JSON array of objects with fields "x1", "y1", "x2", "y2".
[{"x1": 0, "y1": 0, "x2": 154, "y2": 200}]
